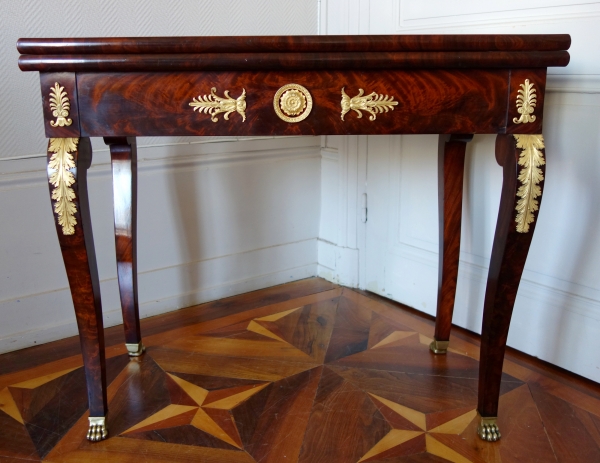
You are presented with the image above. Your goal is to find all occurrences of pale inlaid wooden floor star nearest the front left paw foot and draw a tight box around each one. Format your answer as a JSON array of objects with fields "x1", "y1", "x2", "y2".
[{"x1": 121, "y1": 373, "x2": 271, "y2": 449}]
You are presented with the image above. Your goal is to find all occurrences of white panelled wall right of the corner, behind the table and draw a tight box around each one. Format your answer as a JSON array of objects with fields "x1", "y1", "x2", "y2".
[{"x1": 319, "y1": 0, "x2": 600, "y2": 381}]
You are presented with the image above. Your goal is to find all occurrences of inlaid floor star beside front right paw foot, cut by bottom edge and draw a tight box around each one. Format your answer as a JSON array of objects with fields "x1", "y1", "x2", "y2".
[{"x1": 358, "y1": 393, "x2": 477, "y2": 463}]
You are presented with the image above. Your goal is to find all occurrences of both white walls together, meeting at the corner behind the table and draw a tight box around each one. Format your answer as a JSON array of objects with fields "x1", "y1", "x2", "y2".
[{"x1": 0, "y1": 0, "x2": 600, "y2": 381}]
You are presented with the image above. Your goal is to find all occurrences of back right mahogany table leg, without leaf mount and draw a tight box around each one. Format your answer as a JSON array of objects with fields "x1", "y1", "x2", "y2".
[{"x1": 429, "y1": 135, "x2": 473, "y2": 354}]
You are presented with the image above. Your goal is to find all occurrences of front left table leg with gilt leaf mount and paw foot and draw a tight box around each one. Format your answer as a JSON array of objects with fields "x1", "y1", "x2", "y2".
[{"x1": 47, "y1": 138, "x2": 108, "y2": 441}]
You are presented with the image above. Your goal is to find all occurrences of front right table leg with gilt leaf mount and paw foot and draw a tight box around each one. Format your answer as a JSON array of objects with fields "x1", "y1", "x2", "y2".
[{"x1": 477, "y1": 135, "x2": 545, "y2": 441}]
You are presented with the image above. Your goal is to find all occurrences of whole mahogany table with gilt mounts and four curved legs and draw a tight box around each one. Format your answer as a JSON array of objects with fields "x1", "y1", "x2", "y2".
[{"x1": 17, "y1": 35, "x2": 571, "y2": 441}]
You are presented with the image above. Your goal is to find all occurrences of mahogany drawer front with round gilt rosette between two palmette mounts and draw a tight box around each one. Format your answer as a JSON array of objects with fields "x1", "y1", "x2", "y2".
[{"x1": 71, "y1": 70, "x2": 524, "y2": 136}]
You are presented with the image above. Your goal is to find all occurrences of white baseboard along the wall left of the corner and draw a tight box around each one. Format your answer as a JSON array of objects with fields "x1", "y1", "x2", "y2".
[{"x1": 0, "y1": 239, "x2": 317, "y2": 353}]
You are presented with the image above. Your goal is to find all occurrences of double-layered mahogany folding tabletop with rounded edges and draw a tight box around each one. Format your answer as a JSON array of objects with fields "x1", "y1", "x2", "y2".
[{"x1": 17, "y1": 34, "x2": 571, "y2": 72}]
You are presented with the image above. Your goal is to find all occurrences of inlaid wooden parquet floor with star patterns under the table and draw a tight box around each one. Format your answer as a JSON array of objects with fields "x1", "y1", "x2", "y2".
[{"x1": 0, "y1": 278, "x2": 600, "y2": 463}]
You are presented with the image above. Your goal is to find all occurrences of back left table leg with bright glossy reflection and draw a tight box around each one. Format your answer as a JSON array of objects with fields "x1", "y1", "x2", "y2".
[{"x1": 104, "y1": 137, "x2": 145, "y2": 357}]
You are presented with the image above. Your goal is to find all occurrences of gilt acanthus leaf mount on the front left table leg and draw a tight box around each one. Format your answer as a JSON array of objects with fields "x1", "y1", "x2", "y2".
[{"x1": 48, "y1": 138, "x2": 79, "y2": 235}]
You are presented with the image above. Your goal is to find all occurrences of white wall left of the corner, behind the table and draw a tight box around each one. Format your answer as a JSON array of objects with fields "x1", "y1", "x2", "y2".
[{"x1": 0, "y1": 0, "x2": 320, "y2": 352}]
